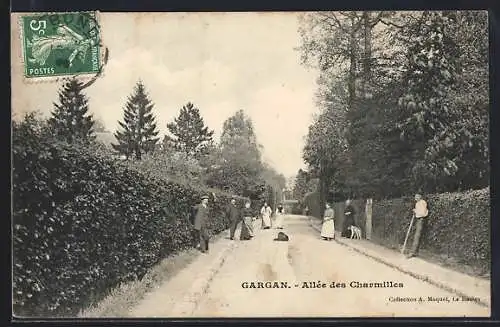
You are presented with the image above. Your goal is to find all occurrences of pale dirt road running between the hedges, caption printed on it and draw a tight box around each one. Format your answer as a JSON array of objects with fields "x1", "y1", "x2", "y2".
[{"x1": 128, "y1": 216, "x2": 489, "y2": 317}]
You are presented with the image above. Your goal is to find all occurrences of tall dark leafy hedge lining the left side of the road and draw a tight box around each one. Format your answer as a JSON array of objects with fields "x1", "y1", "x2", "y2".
[{"x1": 12, "y1": 123, "x2": 246, "y2": 316}]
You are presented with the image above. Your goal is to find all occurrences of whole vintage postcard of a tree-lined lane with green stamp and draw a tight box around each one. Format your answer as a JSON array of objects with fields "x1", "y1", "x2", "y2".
[{"x1": 11, "y1": 11, "x2": 491, "y2": 319}]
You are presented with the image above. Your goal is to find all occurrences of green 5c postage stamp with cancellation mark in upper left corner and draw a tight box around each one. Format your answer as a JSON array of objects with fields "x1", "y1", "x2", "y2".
[{"x1": 20, "y1": 12, "x2": 102, "y2": 78}]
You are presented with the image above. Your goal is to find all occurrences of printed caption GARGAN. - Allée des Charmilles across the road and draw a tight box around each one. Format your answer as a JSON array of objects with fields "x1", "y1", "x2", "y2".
[{"x1": 241, "y1": 280, "x2": 404, "y2": 289}]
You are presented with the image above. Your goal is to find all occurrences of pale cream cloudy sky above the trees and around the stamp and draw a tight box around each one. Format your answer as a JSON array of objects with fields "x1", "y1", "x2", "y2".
[{"x1": 11, "y1": 12, "x2": 318, "y2": 177}]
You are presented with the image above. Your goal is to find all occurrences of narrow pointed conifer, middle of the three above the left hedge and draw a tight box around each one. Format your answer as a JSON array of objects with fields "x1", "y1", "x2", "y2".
[{"x1": 112, "y1": 81, "x2": 159, "y2": 160}]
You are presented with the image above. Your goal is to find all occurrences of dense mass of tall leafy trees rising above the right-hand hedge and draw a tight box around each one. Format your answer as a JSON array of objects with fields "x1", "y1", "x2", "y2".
[{"x1": 301, "y1": 11, "x2": 489, "y2": 200}]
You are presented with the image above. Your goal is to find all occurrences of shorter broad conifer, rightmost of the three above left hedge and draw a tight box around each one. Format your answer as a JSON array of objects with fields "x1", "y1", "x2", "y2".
[{"x1": 164, "y1": 102, "x2": 214, "y2": 157}]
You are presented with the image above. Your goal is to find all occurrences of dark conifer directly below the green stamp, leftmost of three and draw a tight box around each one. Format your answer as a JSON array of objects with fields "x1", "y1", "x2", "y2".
[{"x1": 48, "y1": 78, "x2": 95, "y2": 143}]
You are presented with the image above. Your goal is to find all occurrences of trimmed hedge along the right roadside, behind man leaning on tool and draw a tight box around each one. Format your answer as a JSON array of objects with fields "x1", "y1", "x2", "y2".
[{"x1": 372, "y1": 188, "x2": 491, "y2": 272}]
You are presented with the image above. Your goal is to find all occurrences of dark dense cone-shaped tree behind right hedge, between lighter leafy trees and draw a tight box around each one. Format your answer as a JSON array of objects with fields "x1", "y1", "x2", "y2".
[{"x1": 348, "y1": 86, "x2": 413, "y2": 198}]
